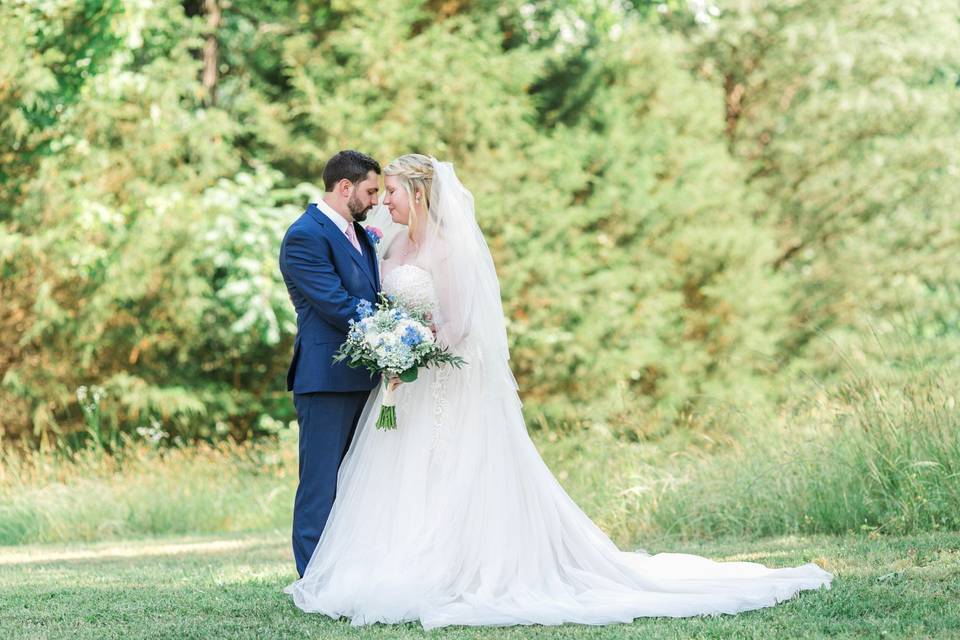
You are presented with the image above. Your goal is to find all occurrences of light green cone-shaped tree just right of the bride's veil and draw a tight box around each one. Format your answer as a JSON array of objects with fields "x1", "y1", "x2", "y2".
[{"x1": 501, "y1": 27, "x2": 786, "y2": 436}]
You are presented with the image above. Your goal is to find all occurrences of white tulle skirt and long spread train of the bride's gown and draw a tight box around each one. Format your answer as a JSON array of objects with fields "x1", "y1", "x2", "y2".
[{"x1": 285, "y1": 366, "x2": 832, "y2": 629}]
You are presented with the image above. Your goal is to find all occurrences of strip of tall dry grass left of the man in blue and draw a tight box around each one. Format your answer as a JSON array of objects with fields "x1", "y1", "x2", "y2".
[{"x1": 0, "y1": 432, "x2": 297, "y2": 545}]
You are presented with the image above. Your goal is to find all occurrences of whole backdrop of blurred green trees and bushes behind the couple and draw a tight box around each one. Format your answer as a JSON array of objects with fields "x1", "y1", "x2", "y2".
[{"x1": 0, "y1": 0, "x2": 960, "y2": 450}]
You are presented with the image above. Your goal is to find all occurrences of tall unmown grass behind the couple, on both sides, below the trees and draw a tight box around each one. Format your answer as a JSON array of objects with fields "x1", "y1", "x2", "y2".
[{"x1": 0, "y1": 336, "x2": 960, "y2": 548}]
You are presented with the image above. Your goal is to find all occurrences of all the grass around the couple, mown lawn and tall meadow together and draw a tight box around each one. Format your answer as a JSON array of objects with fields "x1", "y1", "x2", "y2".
[{"x1": 0, "y1": 340, "x2": 960, "y2": 640}]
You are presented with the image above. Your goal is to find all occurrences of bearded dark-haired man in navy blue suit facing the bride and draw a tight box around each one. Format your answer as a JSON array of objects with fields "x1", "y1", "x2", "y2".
[{"x1": 280, "y1": 150, "x2": 380, "y2": 578}]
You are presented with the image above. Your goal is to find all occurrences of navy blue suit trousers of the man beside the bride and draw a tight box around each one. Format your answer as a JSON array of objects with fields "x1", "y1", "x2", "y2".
[{"x1": 293, "y1": 391, "x2": 370, "y2": 578}]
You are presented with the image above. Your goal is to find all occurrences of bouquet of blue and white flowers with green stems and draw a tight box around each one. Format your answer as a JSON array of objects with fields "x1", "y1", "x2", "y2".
[{"x1": 333, "y1": 294, "x2": 466, "y2": 430}]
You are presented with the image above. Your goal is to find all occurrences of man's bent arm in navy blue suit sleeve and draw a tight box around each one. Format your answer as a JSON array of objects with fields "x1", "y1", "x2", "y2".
[{"x1": 286, "y1": 233, "x2": 360, "y2": 333}]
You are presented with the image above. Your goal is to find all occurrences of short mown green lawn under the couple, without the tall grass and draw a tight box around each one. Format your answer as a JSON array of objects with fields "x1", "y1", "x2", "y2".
[{"x1": 0, "y1": 533, "x2": 960, "y2": 640}]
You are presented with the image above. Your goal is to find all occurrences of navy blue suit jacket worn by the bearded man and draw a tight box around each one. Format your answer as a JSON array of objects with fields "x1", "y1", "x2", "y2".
[{"x1": 280, "y1": 204, "x2": 380, "y2": 393}]
